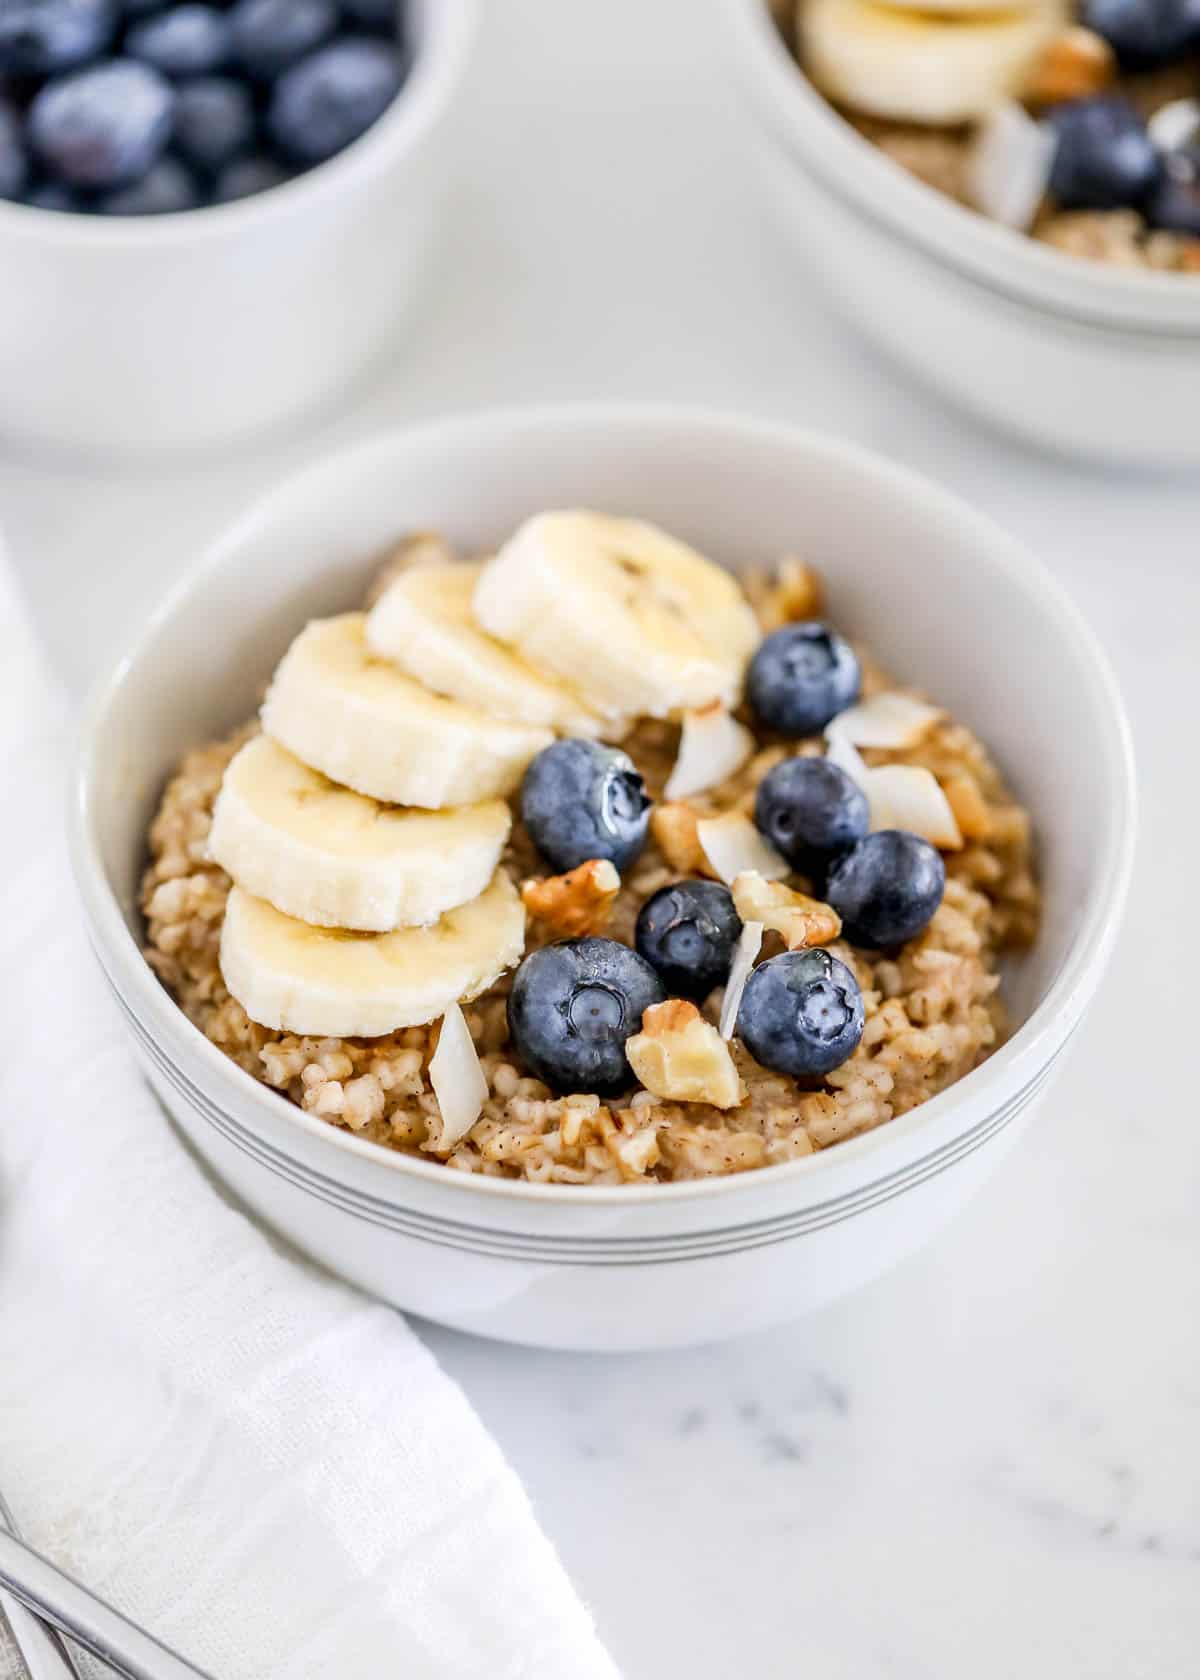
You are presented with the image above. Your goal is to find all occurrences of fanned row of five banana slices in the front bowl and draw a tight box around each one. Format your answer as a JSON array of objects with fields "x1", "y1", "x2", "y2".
[{"x1": 208, "y1": 512, "x2": 758, "y2": 1038}]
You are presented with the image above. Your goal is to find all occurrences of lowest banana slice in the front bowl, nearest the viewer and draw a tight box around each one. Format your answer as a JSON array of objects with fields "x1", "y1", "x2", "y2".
[{"x1": 220, "y1": 870, "x2": 524, "y2": 1038}]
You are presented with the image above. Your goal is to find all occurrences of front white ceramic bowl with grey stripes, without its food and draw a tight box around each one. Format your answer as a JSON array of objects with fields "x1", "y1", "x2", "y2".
[{"x1": 72, "y1": 408, "x2": 1134, "y2": 1349}]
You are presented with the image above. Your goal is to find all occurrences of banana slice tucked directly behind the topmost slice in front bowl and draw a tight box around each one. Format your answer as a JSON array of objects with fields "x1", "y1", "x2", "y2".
[{"x1": 366, "y1": 563, "x2": 602, "y2": 736}]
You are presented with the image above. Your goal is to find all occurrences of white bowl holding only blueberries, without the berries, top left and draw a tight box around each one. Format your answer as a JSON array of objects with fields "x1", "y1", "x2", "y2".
[{"x1": 0, "y1": 0, "x2": 479, "y2": 454}]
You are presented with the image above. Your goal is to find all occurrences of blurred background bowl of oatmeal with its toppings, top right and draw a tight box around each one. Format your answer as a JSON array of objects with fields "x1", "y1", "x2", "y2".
[{"x1": 719, "y1": 0, "x2": 1200, "y2": 467}]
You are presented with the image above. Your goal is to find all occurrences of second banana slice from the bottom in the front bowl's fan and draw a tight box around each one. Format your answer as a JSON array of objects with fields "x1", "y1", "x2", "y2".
[{"x1": 208, "y1": 736, "x2": 513, "y2": 932}]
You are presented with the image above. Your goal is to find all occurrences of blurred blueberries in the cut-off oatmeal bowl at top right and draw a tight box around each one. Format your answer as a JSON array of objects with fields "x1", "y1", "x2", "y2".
[{"x1": 1047, "y1": 0, "x2": 1200, "y2": 239}]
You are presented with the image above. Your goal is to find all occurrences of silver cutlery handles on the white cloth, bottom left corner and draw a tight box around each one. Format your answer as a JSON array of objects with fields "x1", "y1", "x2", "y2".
[{"x1": 0, "y1": 1500, "x2": 212, "y2": 1680}]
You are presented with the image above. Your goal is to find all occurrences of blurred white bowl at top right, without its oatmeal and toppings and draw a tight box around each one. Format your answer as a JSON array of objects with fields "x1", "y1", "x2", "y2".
[{"x1": 718, "y1": 0, "x2": 1200, "y2": 467}]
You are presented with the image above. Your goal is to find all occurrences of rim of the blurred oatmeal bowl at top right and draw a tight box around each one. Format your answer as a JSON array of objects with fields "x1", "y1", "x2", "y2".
[{"x1": 723, "y1": 0, "x2": 1200, "y2": 338}]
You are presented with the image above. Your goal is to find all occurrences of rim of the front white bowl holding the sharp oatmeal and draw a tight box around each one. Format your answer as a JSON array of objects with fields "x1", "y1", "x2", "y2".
[{"x1": 69, "y1": 403, "x2": 1136, "y2": 1206}]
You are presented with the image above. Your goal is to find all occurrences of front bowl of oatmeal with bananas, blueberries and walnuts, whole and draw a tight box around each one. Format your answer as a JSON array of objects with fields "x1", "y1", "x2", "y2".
[{"x1": 72, "y1": 408, "x2": 1133, "y2": 1347}]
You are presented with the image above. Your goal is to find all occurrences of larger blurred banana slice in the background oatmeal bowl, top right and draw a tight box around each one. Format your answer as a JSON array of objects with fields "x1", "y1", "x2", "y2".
[{"x1": 803, "y1": 0, "x2": 1062, "y2": 124}]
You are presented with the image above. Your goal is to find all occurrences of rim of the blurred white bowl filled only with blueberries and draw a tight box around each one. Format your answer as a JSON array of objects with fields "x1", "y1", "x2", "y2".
[{"x1": 0, "y1": 0, "x2": 479, "y2": 250}]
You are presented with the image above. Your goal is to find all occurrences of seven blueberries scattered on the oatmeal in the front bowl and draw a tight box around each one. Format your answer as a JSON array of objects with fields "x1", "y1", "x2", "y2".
[{"x1": 508, "y1": 620, "x2": 946, "y2": 1097}]
